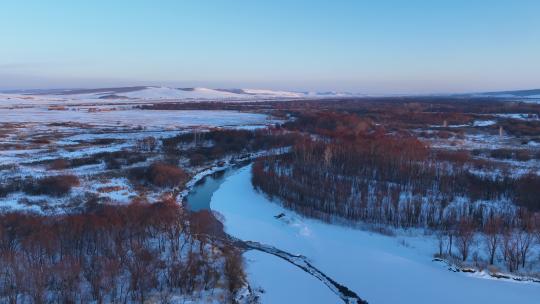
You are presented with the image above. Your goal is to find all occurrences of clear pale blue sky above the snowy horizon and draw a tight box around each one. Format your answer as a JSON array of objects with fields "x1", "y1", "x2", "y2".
[{"x1": 0, "y1": 0, "x2": 540, "y2": 94}]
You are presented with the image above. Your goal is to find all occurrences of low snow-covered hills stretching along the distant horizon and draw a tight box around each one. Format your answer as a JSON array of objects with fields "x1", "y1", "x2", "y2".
[{"x1": 4, "y1": 86, "x2": 540, "y2": 105}]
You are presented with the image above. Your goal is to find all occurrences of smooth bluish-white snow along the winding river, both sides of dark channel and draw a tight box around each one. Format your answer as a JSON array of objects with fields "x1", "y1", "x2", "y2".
[{"x1": 211, "y1": 166, "x2": 540, "y2": 303}]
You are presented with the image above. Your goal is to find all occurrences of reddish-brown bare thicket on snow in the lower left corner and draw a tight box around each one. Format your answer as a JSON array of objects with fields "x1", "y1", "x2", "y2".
[{"x1": 0, "y1": 202, "x2": 245, "y2": 303}]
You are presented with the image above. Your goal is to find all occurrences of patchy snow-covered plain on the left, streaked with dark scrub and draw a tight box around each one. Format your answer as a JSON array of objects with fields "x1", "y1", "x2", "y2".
[{"x1": 0, "y1": 105, "x2": 276, "y2": 212}]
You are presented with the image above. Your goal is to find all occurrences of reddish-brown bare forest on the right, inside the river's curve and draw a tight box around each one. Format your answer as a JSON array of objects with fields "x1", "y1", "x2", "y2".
[{"x1": 252, "y1": 110, "x2": 540, "y2": 272}]
